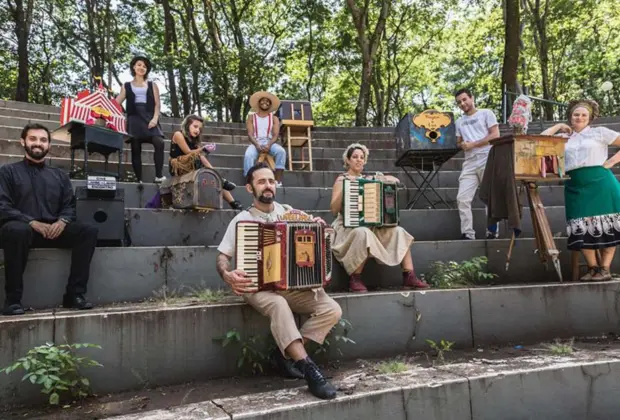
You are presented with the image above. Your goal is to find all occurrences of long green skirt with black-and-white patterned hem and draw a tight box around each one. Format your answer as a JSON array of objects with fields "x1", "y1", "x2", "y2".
[{"x1": 564, "y1": 166, "x2": 620, "y2": 250}]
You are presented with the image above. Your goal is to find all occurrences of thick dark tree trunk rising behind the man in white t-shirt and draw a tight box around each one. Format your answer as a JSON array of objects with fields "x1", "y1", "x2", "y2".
[{"x1": 501, "y1": 0, "x2": 521, "y2": 116}]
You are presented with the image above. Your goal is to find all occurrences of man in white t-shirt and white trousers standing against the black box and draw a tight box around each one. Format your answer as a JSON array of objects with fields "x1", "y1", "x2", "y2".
[{"x1": 454, "y1": 89, "x2": 499, "y2": 239}]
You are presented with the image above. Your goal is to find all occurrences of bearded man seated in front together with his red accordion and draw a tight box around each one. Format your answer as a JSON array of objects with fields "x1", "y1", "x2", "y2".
[{"x1": 217, "y1": 163, "x2": 342, "y2": 399}]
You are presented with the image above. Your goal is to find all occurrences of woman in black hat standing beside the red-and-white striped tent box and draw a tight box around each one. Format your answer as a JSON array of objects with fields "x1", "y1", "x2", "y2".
[{"x1": 116, "y1": 56, "x2": 166, "y2": 183}]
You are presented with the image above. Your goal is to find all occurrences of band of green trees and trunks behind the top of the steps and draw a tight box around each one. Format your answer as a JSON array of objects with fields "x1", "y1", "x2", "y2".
[{"x1": 0, "y1": 0, "x2": 620, "y2": 126}]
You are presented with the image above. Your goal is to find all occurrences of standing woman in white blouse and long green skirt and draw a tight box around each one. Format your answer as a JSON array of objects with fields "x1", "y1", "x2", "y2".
[{"x1": 541, "y1": 100, "x2": 620, "y2": 281}]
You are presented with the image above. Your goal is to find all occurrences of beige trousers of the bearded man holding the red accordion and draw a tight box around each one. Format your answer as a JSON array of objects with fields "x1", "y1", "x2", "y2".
[{"x1": 244, "y1": 289, "x2": 342, "y2": 356}]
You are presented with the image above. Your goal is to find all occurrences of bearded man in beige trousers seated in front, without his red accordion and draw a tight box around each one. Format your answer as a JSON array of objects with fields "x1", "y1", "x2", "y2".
[{"x1": 217, "y1": 163, "x2": 342, "y2": 399}]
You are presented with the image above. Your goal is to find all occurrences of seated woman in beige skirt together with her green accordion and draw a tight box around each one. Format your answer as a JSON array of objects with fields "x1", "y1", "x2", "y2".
[{"x1": 330, "y1": 143, "x2": 429, "y2": 292}]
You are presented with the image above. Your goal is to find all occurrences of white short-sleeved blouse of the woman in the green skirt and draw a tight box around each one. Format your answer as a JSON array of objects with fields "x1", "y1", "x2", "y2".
[{"x1": 564, "y1": 126, "x2": 620, "y2": 172}]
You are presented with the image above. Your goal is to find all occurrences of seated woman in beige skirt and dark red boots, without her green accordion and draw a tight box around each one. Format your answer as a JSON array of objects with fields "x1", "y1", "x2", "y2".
[{"x1": 330, "y1": 143, "x2": 429, "y2": 292}]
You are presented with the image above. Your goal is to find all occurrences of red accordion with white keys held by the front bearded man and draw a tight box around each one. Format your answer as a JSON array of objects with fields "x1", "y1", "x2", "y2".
[{"x1": 235, "y1": 212, "x2": 332, "y2": 291}]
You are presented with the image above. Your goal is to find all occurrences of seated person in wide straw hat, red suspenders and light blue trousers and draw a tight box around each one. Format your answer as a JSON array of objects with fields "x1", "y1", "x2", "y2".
[{"x1": 243, "y1": 91, "x2": 286, "y2": 187}]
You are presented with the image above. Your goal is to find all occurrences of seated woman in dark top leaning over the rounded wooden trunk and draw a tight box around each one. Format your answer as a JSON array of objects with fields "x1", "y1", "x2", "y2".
[{"x1": 168, "y1": 115, "x2": 243, "y2": 210}]
